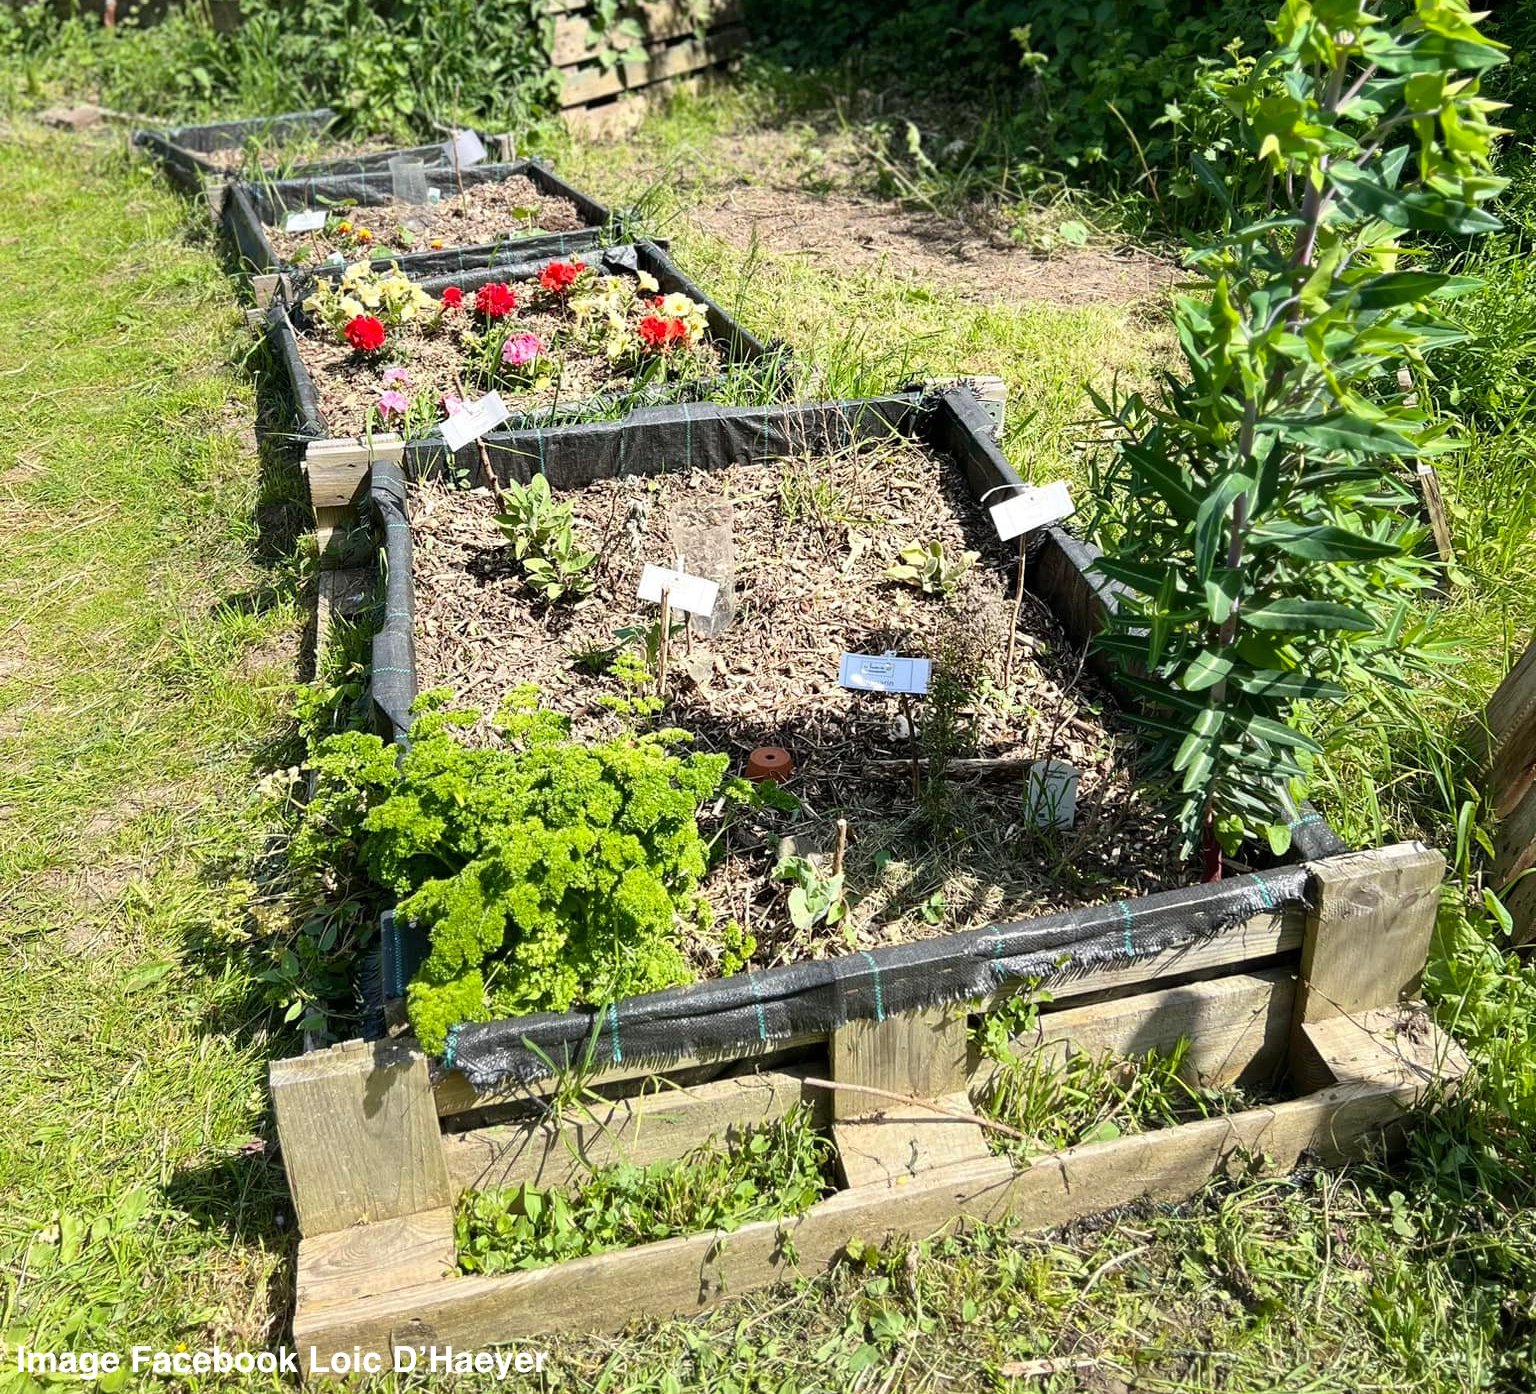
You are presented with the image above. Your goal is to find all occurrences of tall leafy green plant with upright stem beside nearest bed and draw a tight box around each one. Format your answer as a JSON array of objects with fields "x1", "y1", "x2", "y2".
[{"x1": 1098, "y1": 0, "x2": 1502, "y2": 861}]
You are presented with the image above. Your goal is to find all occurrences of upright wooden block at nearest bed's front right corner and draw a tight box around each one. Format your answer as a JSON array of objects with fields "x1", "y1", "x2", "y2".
[{"x1": 1296, "y1": 843, "x2": 1445, "y2": 1024}]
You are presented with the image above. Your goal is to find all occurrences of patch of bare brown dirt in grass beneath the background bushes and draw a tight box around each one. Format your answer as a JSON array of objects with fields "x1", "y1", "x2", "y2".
[{"x1": 691, "y1": 184, "x2": 1178, "y2": 306}]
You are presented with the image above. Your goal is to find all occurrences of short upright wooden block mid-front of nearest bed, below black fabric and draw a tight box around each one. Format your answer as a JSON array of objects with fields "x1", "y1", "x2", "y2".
[{"x1": 828, "y1": 1006, "x2": 971, "y2": 1119}]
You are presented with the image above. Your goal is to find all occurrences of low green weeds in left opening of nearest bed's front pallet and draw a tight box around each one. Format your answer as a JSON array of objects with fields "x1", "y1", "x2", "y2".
[{"x1": 453, "y1": 1108, "x2": 831, "y2": 1273}]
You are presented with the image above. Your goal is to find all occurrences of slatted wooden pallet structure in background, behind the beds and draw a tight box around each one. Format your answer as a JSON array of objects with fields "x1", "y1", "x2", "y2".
[{"x1": 551, "y1": 0, "x2": 746, "y2": 135}]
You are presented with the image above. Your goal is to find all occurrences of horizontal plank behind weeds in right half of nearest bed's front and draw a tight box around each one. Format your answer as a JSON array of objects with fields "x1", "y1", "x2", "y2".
[{"x1": 971, "y1": 969, "x2": 1296, "y2": 1095}]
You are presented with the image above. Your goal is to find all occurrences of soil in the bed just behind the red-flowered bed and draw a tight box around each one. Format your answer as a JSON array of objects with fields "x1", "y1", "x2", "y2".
[{"x1": 267, "y1": 172, "x2": 585, "y2": 266}]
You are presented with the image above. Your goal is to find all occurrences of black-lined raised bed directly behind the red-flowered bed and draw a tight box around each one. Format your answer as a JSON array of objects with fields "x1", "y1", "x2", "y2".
[{"x1": 223, "y1": 158, "x2": 617, "y2": 306}]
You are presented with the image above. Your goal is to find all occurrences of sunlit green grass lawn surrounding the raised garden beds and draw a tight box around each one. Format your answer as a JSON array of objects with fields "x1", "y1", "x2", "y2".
[{"x1": 0, "y1": 95, "x2": 1536, "y2": 1394}]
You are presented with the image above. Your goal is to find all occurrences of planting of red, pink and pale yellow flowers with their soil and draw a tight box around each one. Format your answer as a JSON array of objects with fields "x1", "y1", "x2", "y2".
[{"x1": 298, "y1": 258, "x2": 723, "y2": 438}]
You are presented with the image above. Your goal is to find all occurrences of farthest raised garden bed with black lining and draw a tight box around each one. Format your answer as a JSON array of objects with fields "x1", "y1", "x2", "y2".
[{"x1": 134, "y1": 107, "x2": 510, "y2": 192}]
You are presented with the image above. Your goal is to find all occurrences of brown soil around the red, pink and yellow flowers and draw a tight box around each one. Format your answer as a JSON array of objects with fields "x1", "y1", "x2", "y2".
[{"x1": 298, "y1": 267, "x2": 723, "y2": 436}]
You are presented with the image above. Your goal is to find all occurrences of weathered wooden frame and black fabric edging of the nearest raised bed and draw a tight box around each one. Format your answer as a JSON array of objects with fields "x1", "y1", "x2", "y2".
[{"x1": 272, "y1": 391, "x2": 1464, "y2": 1354}]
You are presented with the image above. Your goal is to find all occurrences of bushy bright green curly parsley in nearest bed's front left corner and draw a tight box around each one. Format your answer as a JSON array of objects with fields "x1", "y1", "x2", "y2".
[{"x1": 298, "y1": 688, "x2": 750, "y2": 1052}]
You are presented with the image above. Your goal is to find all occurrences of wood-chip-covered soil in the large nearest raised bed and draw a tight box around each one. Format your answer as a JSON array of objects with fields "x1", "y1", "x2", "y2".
[{"x1": 412, "y1": 444, "x2": 1192, "y2": 973}]
